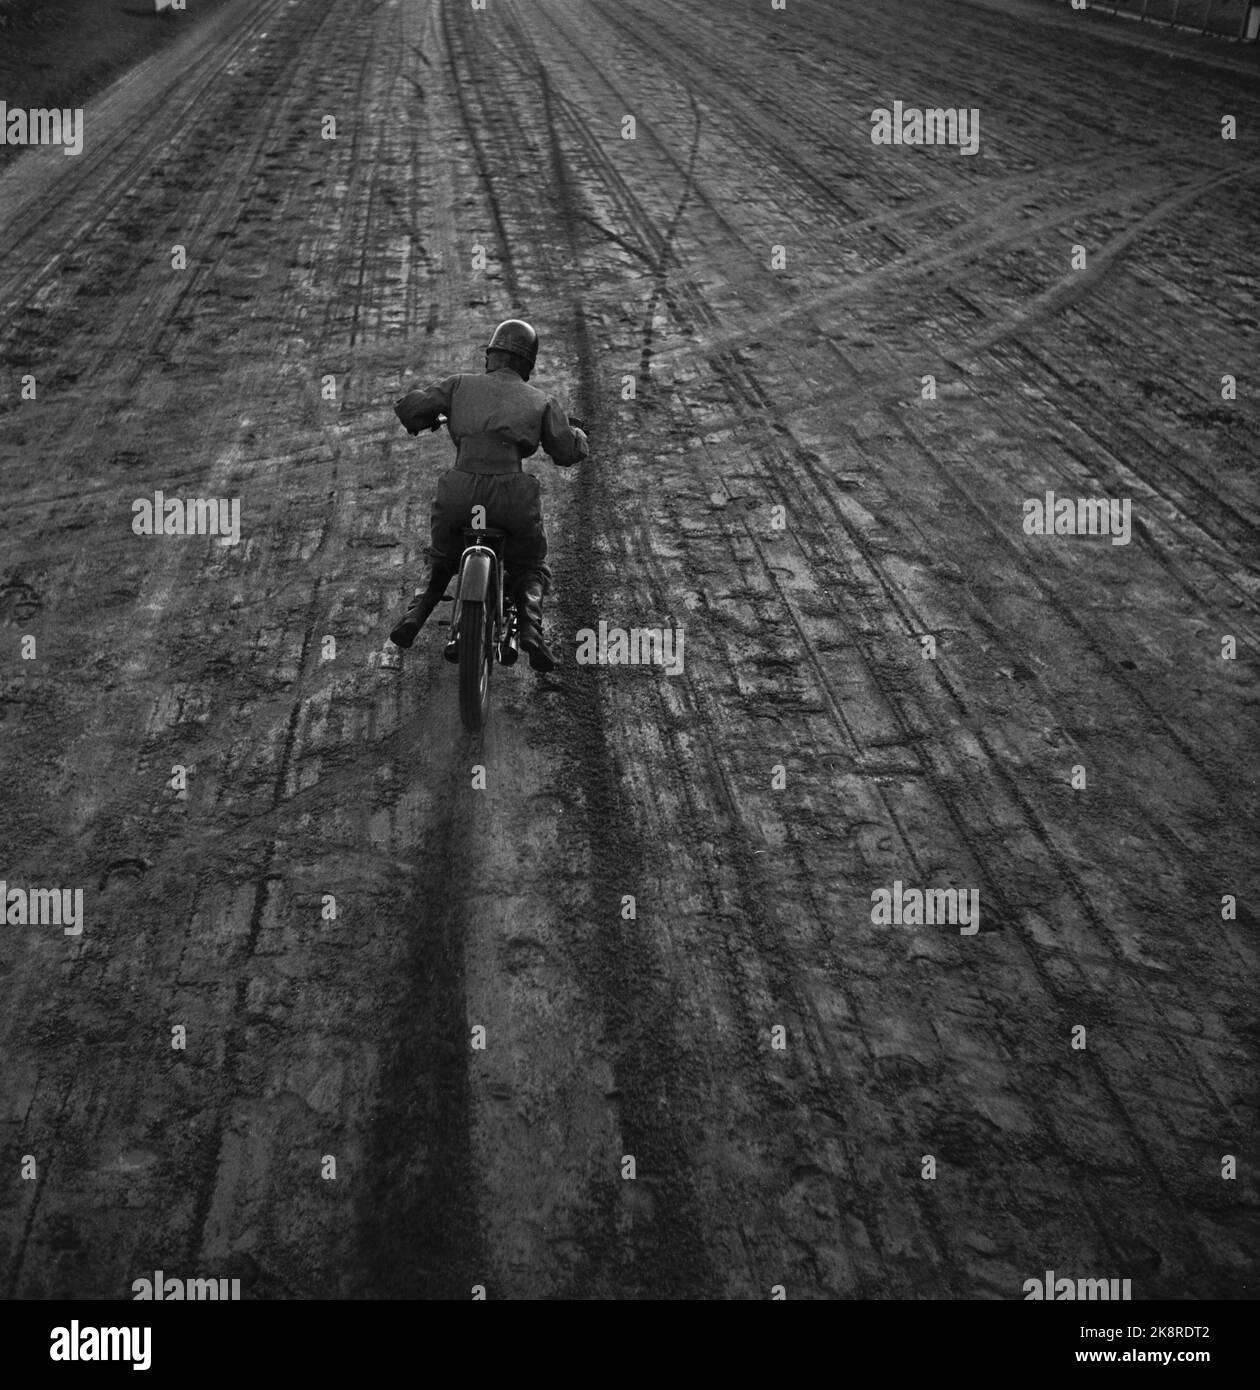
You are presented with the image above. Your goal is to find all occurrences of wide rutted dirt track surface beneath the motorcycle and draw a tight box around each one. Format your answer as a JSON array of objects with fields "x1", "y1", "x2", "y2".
[{"x1": 0, "y1": 0, "x2": 1260, "y2": 1298}]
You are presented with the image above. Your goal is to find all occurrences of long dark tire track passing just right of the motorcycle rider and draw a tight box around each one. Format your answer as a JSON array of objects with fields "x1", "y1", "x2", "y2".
[{"x1": 442, "y1": 0, "x2": 711, "y2": 1297}]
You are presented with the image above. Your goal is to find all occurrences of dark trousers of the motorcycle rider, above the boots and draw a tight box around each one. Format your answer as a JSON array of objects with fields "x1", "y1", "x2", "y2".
[{"x1": 428, "y1": 468, "x2": 551, "y2": 595}]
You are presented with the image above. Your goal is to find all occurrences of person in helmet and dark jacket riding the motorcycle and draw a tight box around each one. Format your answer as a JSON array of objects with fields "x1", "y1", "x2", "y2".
[{"x1": 389, "y1": 318, "x2": 590, "y2": 671}]
